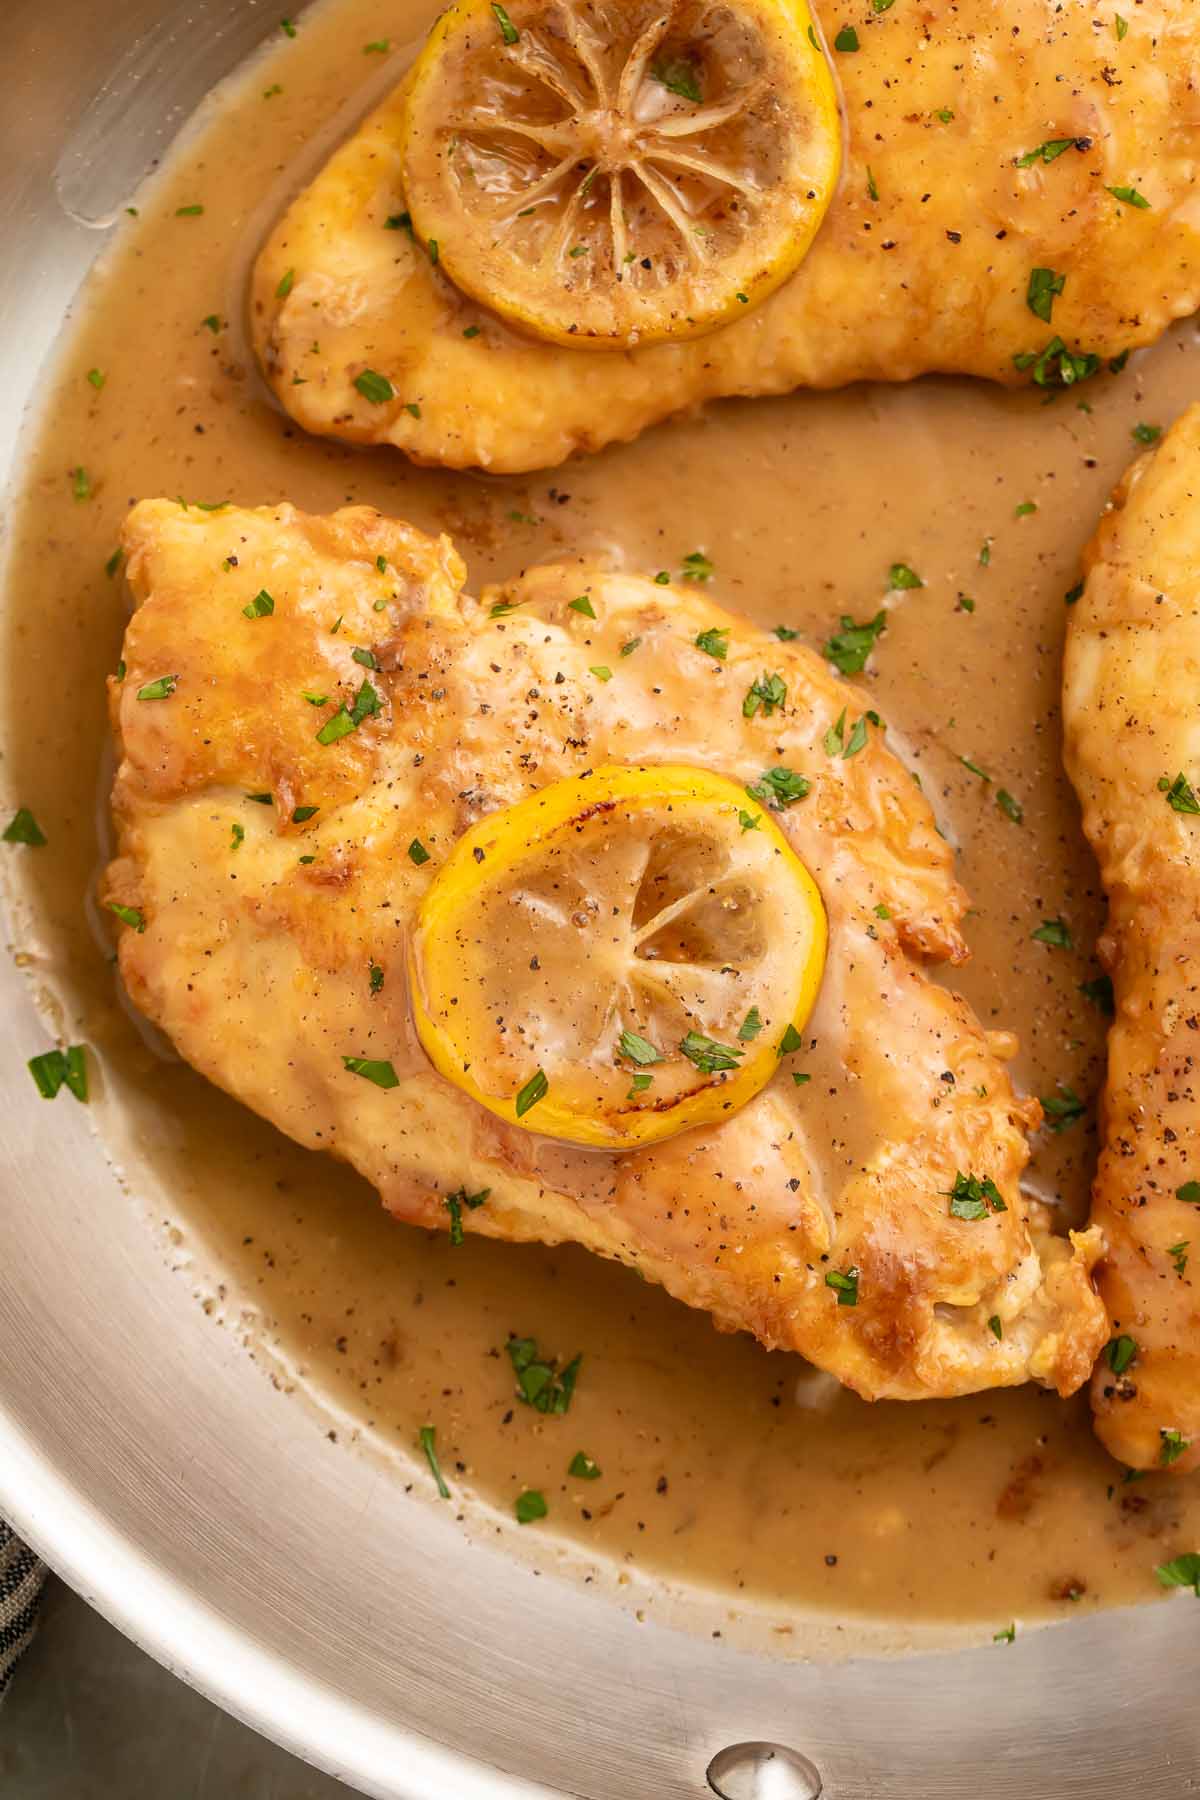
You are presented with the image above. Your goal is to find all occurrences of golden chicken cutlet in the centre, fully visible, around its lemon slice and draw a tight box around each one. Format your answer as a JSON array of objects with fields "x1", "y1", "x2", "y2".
[{"x1": 106, "y1": 500, "x2": 1106, "y2": 1399}]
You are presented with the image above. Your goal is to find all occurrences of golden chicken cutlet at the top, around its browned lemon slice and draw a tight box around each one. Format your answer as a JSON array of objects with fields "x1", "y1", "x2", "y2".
[{"x1": 250, "y1": 0, "x2": 1200, "y2": 472}]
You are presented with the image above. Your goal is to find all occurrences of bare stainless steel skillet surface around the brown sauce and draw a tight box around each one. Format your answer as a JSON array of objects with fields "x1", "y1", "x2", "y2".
[{"x1": 0, "y1": 0, "x2": 1200, "y2": 1800}]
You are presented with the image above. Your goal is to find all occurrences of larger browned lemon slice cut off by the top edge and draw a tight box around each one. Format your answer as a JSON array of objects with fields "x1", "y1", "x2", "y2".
[{"x1": 401, "y1": 0, "x2": 842, "y2": 347}]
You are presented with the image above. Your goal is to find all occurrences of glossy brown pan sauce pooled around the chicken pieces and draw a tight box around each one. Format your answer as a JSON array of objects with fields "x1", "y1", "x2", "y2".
[{"x1": 5, "y1": 0, "x2": 1200, "y2": 1636}]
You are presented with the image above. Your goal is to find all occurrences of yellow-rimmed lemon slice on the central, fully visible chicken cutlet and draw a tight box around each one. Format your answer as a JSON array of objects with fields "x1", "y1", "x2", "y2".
[{"x1": 410, "y1": 767, "x2": 826, "y2": 1150}]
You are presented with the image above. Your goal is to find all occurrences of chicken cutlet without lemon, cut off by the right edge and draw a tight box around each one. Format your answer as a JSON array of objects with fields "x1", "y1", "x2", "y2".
[{"x1": 1063, "y1": 407, "x2": 1200, "y2": 1471}]
